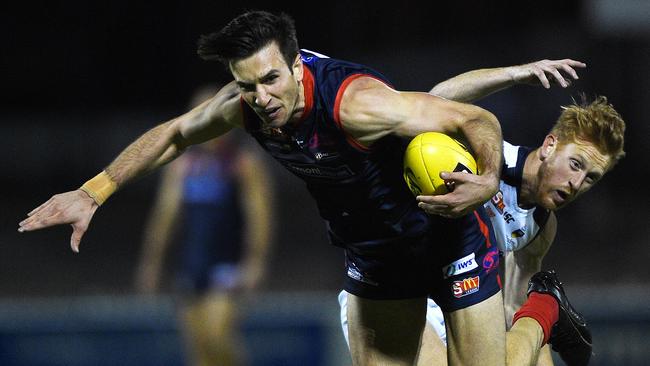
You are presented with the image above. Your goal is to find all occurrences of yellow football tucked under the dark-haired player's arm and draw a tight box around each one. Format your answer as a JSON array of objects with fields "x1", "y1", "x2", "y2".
[{"x1": 404, "y1": 132, "x2": 478, "y2": 196}]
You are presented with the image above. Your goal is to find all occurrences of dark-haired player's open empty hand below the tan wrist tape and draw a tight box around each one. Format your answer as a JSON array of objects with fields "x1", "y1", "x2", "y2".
[{"x1": 18, "y1": 189, "x2": 99, "y2": 253}]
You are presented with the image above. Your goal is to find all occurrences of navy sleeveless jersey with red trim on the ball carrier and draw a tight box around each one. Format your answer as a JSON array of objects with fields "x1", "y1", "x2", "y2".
[{"x1": 242, "y1": 50, "x2": 428, "y2": 246}]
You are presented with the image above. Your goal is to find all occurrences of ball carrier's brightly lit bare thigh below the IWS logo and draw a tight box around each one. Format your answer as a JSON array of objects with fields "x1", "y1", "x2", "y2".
[{"x1": 445, "y1": 291, "x2": 506, "y2": 366}]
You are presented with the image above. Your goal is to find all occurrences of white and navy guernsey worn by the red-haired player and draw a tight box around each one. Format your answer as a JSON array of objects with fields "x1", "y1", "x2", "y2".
[{"x1": 484, "y1": 141, "x2": 549, "y2": 252}]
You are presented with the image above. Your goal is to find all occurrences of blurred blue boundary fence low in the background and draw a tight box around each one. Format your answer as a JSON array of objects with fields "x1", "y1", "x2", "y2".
[{"x1": 0, "y1": 286, "x2": 650, "y2": 366}]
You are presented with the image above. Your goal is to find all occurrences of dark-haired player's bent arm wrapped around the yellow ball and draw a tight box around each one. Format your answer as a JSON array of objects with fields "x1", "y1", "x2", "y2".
[{"x1": 339, "y1": 77, "x2": 502, "y2": 217}]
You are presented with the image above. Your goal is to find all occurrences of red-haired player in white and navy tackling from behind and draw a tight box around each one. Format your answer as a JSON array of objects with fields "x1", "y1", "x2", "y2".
[{"x1": 339, "y1": 59, "x2": 625, "y2": 365}]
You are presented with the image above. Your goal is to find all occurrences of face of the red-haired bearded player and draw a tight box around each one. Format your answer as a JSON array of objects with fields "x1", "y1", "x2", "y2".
[{"x1": 537, "y1": 137, "x2": 611, "y2": 210}]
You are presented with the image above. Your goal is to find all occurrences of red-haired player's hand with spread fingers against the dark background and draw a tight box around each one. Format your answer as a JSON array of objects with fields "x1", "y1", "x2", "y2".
[{"x1": 508, "y1": 59, "x2": 587, "y2": 89}]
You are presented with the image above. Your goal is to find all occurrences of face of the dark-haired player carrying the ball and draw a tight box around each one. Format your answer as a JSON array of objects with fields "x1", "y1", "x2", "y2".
[{"x1": 230, "y1": 42, "x2": 304, "y2": 127}]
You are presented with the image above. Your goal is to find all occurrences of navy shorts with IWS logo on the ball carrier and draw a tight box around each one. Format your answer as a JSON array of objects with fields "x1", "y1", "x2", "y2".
[{"x1": 344, "y1": 207, "x2": 501, "y2": 312}]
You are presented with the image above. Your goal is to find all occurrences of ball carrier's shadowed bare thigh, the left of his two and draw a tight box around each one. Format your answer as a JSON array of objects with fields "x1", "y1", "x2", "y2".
[{"x1": 348, "y1": 294, "x2": 426, "y2": 366}]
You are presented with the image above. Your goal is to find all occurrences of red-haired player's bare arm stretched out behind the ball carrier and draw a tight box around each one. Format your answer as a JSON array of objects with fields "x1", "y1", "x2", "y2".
[{"x1": 429, "y1": 59, "x2": 587, "y2": 103}]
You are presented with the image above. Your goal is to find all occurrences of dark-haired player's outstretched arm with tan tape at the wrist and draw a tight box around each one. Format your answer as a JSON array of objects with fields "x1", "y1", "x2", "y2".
[{"x1": 18, "y1": 83, "x2": 241, "y2": 252}]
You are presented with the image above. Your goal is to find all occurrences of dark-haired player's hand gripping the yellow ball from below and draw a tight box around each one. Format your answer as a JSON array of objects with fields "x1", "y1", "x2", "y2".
[{"x1": 416, "y1": 172, "x2": 499, "y2": 218}]
